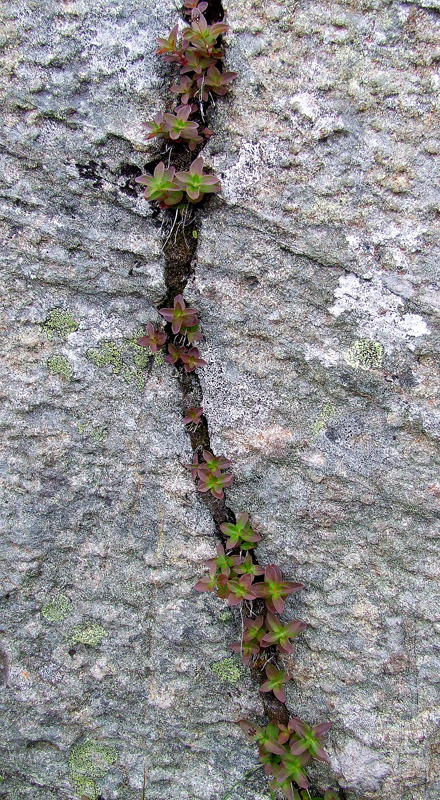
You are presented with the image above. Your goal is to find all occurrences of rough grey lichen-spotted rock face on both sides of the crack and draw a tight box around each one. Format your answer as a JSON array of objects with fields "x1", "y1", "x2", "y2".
[{"x1": 0, "y1": 0, "x2": 440, "y2": 800}]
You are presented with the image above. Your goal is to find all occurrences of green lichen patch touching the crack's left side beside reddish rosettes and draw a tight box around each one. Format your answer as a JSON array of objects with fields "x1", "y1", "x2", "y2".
[{"x1": 87, "y1": 328, "x2": 152, "y2": 391}]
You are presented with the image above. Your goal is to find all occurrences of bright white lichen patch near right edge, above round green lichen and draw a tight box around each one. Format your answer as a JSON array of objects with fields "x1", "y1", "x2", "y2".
[{"x1": 329, "y1": 274, "x2": 430, "y2": 349}]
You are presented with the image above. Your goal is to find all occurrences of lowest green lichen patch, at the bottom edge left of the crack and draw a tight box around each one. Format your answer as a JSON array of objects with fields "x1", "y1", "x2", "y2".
[{"x1": 69, "y1": 739, "x2": 118, "y2": 797}]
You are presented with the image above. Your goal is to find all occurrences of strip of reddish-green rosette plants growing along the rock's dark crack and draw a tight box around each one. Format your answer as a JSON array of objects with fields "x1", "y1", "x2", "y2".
[{"x1": 136, "y1": 6, "x2": 340, "y2": 800}]
